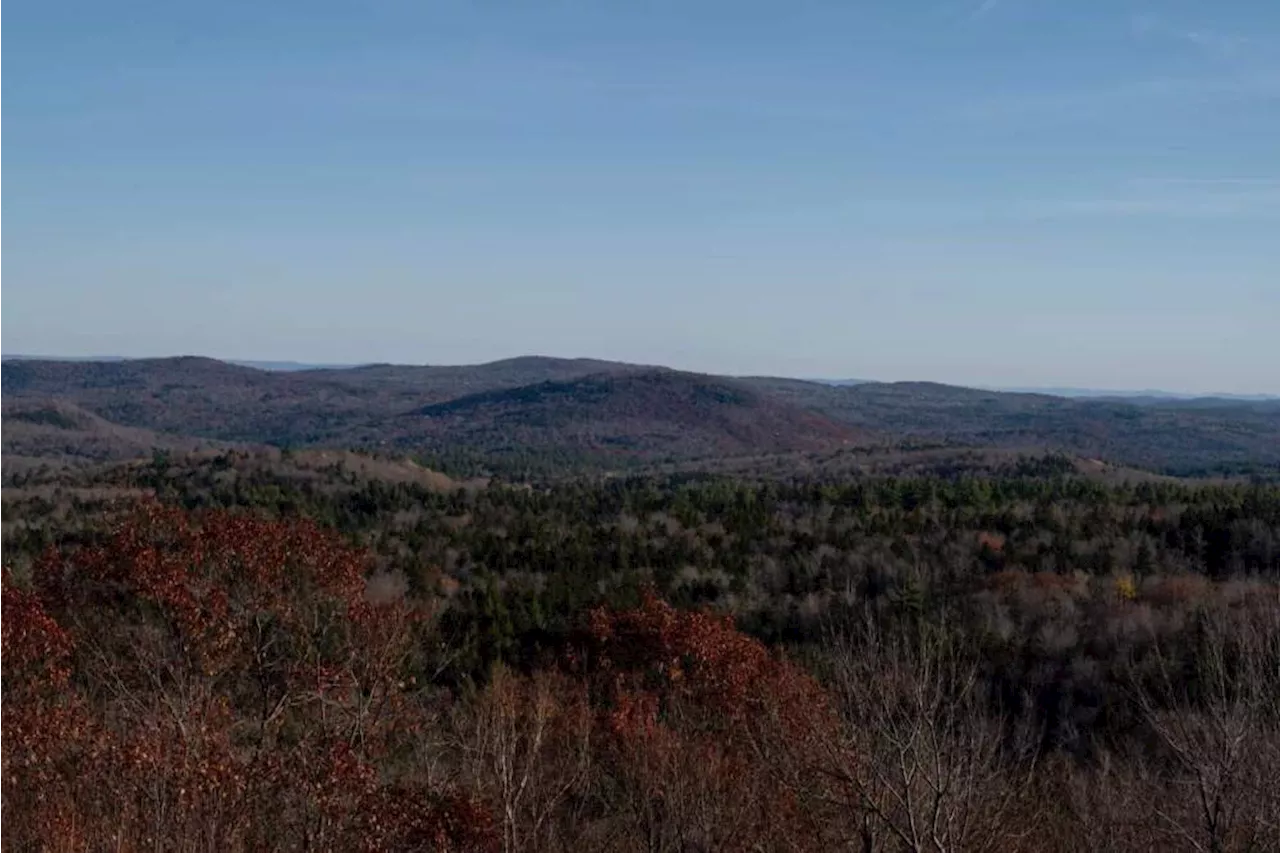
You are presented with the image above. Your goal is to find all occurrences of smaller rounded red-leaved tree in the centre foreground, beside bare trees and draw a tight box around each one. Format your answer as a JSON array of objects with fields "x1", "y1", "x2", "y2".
[{"x1": 580, "y1": 594, "x2": 838, "y2": 850}]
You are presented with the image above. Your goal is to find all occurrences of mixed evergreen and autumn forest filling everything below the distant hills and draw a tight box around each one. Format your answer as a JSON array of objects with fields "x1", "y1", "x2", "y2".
[{"x1": 0, "y1": 450, "x2": 1280, "y2": 850}]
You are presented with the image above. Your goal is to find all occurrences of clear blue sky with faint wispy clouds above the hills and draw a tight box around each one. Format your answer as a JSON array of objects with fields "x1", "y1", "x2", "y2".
[{"x1": 0, "y1": 0, "x2": 1280, "y2": 392}]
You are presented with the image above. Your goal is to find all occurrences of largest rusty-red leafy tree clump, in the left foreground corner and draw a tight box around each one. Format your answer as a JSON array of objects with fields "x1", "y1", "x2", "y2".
[{"x1": 0, "y1": 505, "x2": 494, "y2": 850}]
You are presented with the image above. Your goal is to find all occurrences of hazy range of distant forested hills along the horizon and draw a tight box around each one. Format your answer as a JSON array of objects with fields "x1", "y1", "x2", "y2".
[{"x1": 0, "y1": 357, "x2": 1280, "y2": 475}]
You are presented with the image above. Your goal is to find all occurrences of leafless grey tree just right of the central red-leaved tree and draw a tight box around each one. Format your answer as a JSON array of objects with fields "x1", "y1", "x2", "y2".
[{"x1": 831, "y1": 624, "x2": 1033, "y2": 853}]
